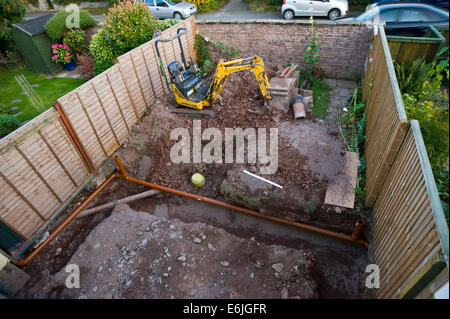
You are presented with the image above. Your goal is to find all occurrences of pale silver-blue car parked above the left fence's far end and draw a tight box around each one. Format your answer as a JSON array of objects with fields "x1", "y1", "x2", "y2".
[{"x1": 142, "y1": 0, "x2": 197, "y2": 19}]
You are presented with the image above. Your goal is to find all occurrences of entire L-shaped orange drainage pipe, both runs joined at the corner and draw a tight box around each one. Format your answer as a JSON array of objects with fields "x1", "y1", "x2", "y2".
[{"x1": 17, "y1": 155, "x2": 369, "y2": 266}]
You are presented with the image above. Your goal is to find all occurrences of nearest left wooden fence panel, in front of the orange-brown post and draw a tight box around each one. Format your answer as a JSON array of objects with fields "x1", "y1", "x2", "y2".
[{"x1": 0, "y1": 109, "x2": 89, "y2": 239}]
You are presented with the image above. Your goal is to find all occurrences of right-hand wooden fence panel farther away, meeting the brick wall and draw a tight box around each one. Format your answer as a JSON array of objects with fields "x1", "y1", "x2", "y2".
[{"x1": 363, "y1": 26, "x2": 407, "y2": 207}]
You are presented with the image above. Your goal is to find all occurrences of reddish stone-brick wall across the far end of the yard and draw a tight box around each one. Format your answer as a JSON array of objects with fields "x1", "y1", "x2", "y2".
[{"x1": 197, "y1": 20, "x2": 372, "y2": 79}]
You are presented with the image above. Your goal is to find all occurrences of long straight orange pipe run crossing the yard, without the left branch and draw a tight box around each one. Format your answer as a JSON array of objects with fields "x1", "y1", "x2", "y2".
[{"x1": 114, "y1": 156, "x2": 369, "y2": 248}]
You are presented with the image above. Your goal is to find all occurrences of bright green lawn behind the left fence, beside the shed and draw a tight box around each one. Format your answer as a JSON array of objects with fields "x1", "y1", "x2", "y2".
[{"x1": 0, "y1": 66, "x2": 85, "y2": 122}]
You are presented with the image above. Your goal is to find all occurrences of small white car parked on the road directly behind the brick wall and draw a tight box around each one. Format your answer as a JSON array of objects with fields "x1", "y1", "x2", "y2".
[{"x1": 281, "y1": 0, "x2": 348, "y2": 20}]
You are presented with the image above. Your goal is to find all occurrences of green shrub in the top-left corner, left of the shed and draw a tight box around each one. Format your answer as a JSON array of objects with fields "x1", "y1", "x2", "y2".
[{"x1": 0, "y1": 0, "x2": 29, "y2": 41}]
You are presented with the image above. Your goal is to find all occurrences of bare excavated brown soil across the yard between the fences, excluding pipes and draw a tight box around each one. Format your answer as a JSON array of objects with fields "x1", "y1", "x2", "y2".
[{"x1": 17, "y1": 63, "x2": 370, "y2": 298}]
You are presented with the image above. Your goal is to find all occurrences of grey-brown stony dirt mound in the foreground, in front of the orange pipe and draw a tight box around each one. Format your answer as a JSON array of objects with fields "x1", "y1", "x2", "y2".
[{"x1": 40, "y1": 205, "x2": 318, "y2": 299}]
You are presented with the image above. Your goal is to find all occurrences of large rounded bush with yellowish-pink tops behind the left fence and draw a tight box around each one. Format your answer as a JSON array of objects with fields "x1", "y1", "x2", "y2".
[{"x1": 104, "y1": 1, "x2": 156, "y2": 53}]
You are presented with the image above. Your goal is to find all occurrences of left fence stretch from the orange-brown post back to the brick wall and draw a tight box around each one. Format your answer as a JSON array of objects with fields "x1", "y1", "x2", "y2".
[{"x1": 58, "y1": 17, "x2": 195, "y2": 169}]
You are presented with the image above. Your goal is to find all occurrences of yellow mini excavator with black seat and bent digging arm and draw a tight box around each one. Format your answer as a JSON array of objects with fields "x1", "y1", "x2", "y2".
[{"x1": 155, "y1": 28, "x2": 272, "y2": 110}]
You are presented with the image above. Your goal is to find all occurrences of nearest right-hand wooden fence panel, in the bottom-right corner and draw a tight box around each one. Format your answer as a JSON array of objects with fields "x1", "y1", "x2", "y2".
[{"x1": 373, "y1": 121, "x2": 448, "y2": 298}]
